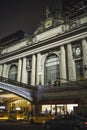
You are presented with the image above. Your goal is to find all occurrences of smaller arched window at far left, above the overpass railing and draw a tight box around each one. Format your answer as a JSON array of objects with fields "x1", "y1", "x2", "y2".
[{"x1": 9, "y1": 65, "x2": 17, "y2": 81}]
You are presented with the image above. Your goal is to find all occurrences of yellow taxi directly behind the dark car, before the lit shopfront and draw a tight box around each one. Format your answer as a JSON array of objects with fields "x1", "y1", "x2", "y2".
[{"x1": 29, "y1": 113, "x2": 53, "y2": 124}]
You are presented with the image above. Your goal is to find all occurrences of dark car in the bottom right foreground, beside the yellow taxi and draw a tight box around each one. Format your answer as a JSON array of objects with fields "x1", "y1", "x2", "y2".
[{"x1": 43, "y1": 114, "x2": 87, "y2": 130}]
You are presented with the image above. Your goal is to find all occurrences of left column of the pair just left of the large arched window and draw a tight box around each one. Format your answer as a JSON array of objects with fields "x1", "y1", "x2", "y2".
[{"x1": 31, "y1": 55, "x2": 36, "y2": 85}]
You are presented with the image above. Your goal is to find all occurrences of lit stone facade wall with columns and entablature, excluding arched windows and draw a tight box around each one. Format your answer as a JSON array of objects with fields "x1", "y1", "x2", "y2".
[{"x1": 0, "y1": 9, "x2": 87, "y2": 109}]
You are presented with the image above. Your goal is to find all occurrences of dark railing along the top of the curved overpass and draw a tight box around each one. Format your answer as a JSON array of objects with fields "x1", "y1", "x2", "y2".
[{"x1": 0, "y1": 76, "x2": 36, "y2": 90}]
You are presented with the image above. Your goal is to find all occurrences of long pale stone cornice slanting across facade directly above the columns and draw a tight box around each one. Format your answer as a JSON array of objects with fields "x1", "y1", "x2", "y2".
[{"x1": 0, "y1": 31, "x2": 87, "y2": 64}]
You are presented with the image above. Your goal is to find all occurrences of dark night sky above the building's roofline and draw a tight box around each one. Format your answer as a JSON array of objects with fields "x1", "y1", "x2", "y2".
[{"x1": 0, "y1": 0, "x2": 61, "y2": 39}]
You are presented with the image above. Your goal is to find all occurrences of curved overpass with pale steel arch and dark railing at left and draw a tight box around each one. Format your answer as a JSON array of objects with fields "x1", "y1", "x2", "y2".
[{"x1": 0, "y1": 77, "x2": 35, "y2": 102}]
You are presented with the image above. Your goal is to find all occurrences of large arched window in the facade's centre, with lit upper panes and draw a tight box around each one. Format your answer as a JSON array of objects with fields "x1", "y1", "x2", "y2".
[{"x1": 44, "y1": 54, "x2": 60, "y2": 84}]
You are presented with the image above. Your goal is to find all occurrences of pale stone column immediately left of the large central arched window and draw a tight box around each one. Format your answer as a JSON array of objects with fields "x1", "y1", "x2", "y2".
[{"x1": 36, "y1": 53, "x2": 42, "y2": 85}]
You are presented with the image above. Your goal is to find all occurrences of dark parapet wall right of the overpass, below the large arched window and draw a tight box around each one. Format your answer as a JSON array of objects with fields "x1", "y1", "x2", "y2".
[{"x1": 38, "y1": 79, "x2": 87, "y2": 92}]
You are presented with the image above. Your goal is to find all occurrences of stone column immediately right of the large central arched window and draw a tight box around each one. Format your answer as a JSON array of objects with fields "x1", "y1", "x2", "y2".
[{"x1": 60, "y1": 46, "x2": 67, "y2": 82}]
